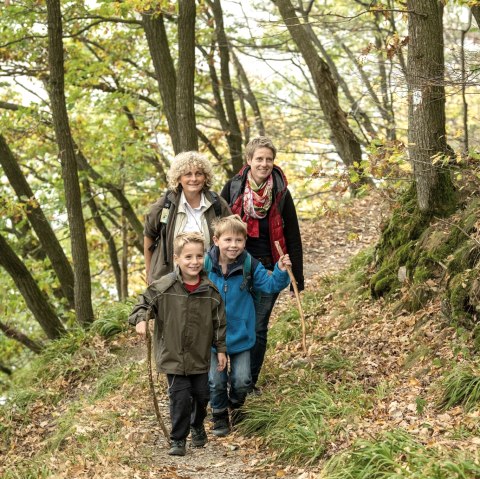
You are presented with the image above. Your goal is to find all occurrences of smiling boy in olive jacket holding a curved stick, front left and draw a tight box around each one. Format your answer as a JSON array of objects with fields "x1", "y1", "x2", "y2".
[{"x1": 128, "y1": 233, "x2": 227, "y2": 456}]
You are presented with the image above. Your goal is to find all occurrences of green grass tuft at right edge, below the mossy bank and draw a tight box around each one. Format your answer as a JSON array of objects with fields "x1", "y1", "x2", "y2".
[{"x1": 439, "y1": 364, "x2": 480, "y2": 411}]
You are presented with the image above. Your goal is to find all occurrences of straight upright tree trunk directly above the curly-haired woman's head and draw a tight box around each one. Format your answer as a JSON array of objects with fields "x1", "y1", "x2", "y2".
[{"x1": 176, "y1": 0, "x2": 198, "y2": 151}]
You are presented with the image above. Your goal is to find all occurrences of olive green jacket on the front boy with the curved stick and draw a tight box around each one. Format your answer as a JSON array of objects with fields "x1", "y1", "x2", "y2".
[{"x1": 128, "y1": 268, "x2": 227, "y2": 375}]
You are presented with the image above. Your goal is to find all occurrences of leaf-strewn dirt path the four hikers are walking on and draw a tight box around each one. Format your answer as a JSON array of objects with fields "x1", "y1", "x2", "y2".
[{"x1": 122, "y1": 194, "x2": 384, "y2": 479}]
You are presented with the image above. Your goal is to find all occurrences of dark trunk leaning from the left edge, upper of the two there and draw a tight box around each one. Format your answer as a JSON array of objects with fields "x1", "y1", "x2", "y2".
[{"x1": 0, "y1": 134, "x2": 75, "y2": 309}]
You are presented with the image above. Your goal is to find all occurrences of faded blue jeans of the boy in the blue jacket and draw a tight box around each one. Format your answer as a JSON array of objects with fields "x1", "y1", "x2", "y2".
[{"x1": 208, "y1": 351, "x2": 252, "y2": 414}]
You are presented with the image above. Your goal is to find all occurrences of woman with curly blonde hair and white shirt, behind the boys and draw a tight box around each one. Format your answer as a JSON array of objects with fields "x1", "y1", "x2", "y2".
[{"x1": 143, "y1": 151, "x2": 231, "y2": 284}]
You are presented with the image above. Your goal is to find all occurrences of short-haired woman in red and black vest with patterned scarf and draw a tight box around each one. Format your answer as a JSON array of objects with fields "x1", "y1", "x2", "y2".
[{"x1": 221, "y1": 136, "x2": 304, "y2": 391}]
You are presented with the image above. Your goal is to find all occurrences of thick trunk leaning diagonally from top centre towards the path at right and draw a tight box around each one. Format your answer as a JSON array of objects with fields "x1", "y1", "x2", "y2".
[{"x1": 274, "y1": 0, "x2": 371, "y2": 189}]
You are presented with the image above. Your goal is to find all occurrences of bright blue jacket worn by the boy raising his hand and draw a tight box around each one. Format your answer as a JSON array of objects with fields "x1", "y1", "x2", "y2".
[{"x1": 207, "y1": 246, "x2": 290, "y2": 354}]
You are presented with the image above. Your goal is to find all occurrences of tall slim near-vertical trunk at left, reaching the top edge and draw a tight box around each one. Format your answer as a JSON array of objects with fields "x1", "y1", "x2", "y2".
[{"x1": 47, "y1": 0, "x2": 93, "y2": 326}]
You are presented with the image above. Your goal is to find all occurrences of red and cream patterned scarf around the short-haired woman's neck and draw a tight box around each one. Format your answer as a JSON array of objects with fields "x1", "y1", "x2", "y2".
[{"x1": 243, "y1": 171, "x2": 273, "y2": 238}]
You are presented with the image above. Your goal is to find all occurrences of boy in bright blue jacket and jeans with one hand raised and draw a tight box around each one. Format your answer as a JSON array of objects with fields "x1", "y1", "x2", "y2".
[{"x1": 206, "y1": 215, "x2": 291, "y2": 436}]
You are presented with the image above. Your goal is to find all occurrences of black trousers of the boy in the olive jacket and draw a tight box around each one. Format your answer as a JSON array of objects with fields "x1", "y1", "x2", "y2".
[{"x1": 167, "y1": 373, "x2": 210, "y2": 441}]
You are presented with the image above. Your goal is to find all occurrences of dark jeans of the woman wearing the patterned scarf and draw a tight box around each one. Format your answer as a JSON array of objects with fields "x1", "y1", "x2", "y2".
[{"x1": 250, "y1": 293, "x2": 278, "y2": 386}]
